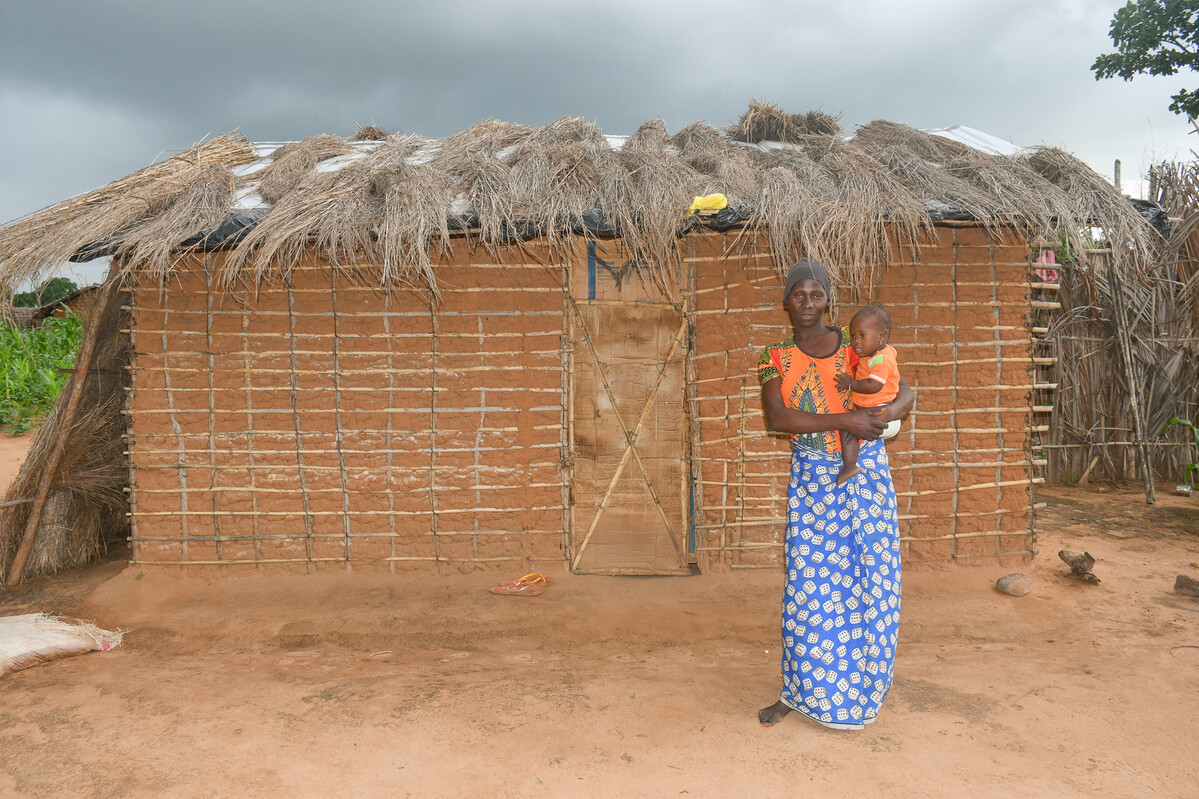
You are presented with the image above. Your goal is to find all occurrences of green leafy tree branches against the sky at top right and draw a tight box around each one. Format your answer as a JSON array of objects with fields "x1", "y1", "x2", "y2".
[{"x1": 1091, "y1": 0, "x2": 1199, "y2": 119}]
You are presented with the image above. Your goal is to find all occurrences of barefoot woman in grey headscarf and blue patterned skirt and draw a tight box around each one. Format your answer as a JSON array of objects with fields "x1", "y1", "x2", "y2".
[{"x1": 758, "y1": 258, "x2": 915, "y2": 729}]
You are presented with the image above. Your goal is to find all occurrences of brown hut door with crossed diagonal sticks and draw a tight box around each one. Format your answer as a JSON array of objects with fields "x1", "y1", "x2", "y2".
[{"x1": 568, "y1": 298, "x2": 689, "y2": 575}]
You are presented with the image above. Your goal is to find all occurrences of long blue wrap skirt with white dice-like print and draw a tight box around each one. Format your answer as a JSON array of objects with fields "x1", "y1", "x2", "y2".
[{"x1": 782, "y1": 441, "x2": 900, "y2": 729}]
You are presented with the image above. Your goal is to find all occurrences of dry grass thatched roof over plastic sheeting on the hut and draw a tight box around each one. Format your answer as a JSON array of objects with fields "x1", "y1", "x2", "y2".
[{"x1": 0, "y1": 103, "x2": 1153, "y2": 290}]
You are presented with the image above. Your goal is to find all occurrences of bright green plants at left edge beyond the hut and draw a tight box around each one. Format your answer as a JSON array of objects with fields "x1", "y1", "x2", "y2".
[{"x1": 0, "y1": 314, "x2": 83, "y2": 435}]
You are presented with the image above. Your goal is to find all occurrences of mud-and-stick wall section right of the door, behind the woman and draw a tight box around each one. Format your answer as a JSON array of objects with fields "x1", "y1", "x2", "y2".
[{"x1": 689, "y1": 224, "x2": 1043, "y2": 569}]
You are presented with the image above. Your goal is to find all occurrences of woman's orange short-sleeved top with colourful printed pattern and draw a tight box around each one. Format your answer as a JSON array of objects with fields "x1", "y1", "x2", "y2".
[{"x1": 758, "y1": 328, "x2": 858, "y2": 455}]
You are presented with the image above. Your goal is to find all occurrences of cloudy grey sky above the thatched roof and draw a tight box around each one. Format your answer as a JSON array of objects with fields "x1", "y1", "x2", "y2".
[{"x1": 0, "y1": 0, "x2": 1199, "y2": 286}]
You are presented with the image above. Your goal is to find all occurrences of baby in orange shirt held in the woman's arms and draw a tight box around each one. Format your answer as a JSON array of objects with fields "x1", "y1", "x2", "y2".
[{"x1": 837, "y1": 305, "x2": 899, "y2": 485}]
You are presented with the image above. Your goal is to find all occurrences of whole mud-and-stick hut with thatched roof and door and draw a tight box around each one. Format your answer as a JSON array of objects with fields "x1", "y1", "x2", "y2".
[{"x1": 0, "y1": 104, "x2": 1149, "y2": 579}]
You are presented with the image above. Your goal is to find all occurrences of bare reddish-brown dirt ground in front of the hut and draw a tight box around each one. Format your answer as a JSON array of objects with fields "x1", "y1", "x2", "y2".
[{"x1": 0, "y1": 429, "x2": 1199, "y2": 797}]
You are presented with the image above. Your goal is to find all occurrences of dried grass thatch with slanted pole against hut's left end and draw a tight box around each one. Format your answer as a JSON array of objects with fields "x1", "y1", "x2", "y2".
[{"x1": 0, "y1": 277, "x2": 129, "y2": 587}]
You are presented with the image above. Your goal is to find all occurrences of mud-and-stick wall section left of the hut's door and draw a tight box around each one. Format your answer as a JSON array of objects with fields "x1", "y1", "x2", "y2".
[{"x1": 128, "y1": 248, "x2": 564, "y2": 570}]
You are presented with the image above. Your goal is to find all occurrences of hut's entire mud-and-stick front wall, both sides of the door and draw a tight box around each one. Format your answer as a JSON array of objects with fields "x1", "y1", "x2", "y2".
[{"x1": 127, "y1": 226, "x2": 1041, "y2": 572}]
